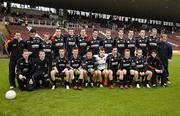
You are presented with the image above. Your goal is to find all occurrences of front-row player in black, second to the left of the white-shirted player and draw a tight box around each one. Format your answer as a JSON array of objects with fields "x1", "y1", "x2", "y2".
[{"x1": 69, "y1": 47, "x2": 84, "y2": 90}]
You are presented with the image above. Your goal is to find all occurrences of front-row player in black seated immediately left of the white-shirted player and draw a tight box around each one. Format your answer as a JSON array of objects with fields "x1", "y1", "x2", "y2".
[{"x1": 83, "y1": 49, "x2": 97, "y2": 87}]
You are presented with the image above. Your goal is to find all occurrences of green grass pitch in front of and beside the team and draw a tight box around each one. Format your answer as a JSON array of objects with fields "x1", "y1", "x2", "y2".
[{"x1": 0, "y1": 56, "x2": 180, "y2": 116}]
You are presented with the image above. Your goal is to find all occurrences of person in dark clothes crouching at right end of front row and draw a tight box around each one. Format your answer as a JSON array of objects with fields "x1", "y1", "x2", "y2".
[{"x1": 147, "y1": 50, "x2": 167, "y2": 87}]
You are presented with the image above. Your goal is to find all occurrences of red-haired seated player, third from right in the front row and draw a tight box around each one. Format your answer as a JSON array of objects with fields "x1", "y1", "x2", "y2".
[{"x1": 120, "y1": 49, "x2": 138, "y2": 89}]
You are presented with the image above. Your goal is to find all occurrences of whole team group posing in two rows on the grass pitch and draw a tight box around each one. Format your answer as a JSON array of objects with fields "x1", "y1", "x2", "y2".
[{"x1": 7, "y1": 28, "x2": 172, "y2": 91}]
